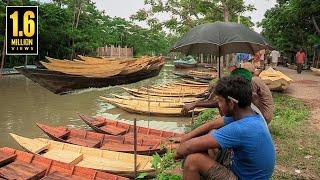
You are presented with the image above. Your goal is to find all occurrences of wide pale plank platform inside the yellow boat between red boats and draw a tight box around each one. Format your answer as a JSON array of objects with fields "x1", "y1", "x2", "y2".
[{"x1": 42, "y1": 150, "x2": 83, "y2": 165}]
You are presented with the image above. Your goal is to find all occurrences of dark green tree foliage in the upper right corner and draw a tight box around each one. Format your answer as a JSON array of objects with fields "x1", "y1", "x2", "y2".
[{"x1": 259, "y1": 0, "x2": 320, "y2": 57}]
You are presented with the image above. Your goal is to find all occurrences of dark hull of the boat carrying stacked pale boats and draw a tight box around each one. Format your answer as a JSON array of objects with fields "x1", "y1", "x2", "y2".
[{"x1": 15, "y1": 61, "x2": 163, "y2": 94}]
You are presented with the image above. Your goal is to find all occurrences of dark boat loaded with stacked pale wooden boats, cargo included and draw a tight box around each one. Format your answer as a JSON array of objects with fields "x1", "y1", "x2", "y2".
[{"x1": 16, "y1": 56, "x2": 164, "y2": 94}]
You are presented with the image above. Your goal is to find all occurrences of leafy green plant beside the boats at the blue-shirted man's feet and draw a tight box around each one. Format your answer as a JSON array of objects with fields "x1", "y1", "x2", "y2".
[{"x1": 152, "y1": 151, "x2": 182, "y2": 180}]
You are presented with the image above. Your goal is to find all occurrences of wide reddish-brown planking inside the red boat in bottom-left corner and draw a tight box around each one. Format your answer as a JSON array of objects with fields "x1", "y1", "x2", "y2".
[{"x1": 0, "y1": 161, "x2": 46, "y2": 179}]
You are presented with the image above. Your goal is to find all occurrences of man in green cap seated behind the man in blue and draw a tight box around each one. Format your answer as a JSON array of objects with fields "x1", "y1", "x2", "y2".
[{"x1": 182, "y1": 66, "x2": 274, "y2": 124}]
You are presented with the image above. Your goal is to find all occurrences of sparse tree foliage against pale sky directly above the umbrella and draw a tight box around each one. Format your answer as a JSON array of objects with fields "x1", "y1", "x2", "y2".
[{"x1": 131, "y1": 0, "x2": 254, "y2": 35}]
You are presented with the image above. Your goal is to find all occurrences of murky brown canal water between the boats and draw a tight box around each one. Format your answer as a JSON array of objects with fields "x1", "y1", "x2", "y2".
[{"x1": 0, "y1": 64, "x2": 196, "y2": 149}]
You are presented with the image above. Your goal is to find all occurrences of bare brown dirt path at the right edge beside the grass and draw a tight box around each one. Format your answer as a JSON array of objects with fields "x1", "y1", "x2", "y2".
[{"x1": 278, "y1": 67, "x2": 320, "y2": 129}]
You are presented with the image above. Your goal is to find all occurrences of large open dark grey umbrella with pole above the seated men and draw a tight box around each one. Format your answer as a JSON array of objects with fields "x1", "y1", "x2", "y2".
[{"x1": 171, "y1": 21, "x2": 271, "y2": 78}]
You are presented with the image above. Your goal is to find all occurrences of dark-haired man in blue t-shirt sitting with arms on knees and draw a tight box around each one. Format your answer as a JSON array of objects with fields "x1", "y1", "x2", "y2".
[{"x1": 175, "y1": 76, "x2": 275, "y2": 180}]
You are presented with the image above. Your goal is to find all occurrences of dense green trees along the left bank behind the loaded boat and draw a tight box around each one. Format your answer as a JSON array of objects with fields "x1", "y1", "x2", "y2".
[{"x1": 0, "y1": 0, "x2": 174, "y2": 67}]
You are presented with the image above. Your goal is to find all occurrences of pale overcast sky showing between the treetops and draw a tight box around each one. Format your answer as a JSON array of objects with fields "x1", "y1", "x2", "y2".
[{"x1": 93, "y1": 0, "x2": 276, "y2": 32}]
